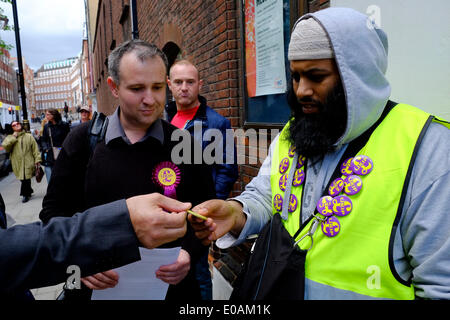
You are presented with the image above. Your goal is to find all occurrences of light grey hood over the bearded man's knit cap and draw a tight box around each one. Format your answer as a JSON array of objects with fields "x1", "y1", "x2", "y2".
[{"x1": 294, "y1": 8, "x2": 391, "y2": 145}]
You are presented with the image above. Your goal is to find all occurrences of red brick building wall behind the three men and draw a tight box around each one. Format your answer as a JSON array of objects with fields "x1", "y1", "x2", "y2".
[{"x1": 86, "y1": 0, "x2": 329, "y2": 292}]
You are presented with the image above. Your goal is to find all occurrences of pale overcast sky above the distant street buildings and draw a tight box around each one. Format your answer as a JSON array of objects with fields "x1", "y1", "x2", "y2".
[{"x1": 0, "y1": 0, "x2": 85, "y2": 71}]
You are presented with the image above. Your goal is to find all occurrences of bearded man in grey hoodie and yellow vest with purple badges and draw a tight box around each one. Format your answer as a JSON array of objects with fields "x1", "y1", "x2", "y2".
[{"x1": 189, "y1": 8, "x2": 450, "y2": 299}]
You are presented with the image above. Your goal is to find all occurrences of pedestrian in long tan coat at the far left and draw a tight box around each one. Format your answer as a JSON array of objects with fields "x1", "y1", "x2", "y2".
[{"x1": 2, "y1": 121, "x2": 41, "y2": 203}]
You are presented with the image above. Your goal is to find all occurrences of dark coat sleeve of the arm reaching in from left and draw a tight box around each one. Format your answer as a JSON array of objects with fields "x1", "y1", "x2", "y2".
[{"x1": 0, "y1": 200, "x2": 140, "y2": 292}]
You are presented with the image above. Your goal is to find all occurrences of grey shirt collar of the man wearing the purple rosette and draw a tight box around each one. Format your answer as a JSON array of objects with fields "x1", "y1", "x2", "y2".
[{"x1": 105, "y1": 107, "x2": 164, "y2": 144}]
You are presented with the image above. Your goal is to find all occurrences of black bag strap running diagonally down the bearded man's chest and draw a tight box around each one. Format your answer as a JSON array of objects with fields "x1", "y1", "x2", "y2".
[{"x1": 293, "y1": 100, "x2": 398, "y2": 239}]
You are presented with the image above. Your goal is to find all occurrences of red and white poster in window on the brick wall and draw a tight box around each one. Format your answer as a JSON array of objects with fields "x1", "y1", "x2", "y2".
[{"x1": 245, "y1": 0, "x2": 286, "y2": 97}]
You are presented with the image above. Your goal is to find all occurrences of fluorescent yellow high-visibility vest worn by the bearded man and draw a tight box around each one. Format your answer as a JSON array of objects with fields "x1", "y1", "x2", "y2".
[{"x1": 271, "y1": 104, "x2": 431, "y2": 299}]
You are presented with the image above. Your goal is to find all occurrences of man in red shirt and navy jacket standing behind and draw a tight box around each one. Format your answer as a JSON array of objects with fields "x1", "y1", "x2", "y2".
[{"x1": 166, "y1": 60, "x2": 238, "y2": 300}]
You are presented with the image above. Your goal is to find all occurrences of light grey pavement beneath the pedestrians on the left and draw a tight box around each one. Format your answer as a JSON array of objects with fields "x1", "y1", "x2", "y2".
[{"x1": 0, "y1": 132, "x2": 63, "y2": 300}]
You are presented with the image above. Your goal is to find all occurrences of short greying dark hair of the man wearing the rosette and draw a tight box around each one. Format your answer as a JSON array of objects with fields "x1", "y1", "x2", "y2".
[{"x1": 108, "y1": 39, "x2": 169, "y2": 84}]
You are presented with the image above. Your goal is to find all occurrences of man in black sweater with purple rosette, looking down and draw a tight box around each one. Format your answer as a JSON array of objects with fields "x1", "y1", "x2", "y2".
[{"x1": 40, "y1": 40, "x2": 214, "y2": 299}]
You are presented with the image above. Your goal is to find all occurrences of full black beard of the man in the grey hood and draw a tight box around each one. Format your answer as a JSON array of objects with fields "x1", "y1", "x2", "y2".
[{"x1": 287, "y1": 82, "x2": 347, "y2": 158}]
